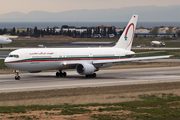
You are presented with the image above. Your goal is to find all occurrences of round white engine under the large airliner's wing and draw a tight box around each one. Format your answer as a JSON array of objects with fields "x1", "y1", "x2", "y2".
[{"x1": 76, "y1": 63, "x2": 96, "y2": 75}]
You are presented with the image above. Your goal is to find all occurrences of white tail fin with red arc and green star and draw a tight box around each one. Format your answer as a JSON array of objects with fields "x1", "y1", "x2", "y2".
[{"x1": 114, "y1": 15, "x2": 138, "y2": 50}]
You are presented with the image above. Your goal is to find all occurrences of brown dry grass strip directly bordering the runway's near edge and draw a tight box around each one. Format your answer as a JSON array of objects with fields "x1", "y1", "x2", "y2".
[{"x1": 0, "y1": 82, "x2": 180, "y2": 101}]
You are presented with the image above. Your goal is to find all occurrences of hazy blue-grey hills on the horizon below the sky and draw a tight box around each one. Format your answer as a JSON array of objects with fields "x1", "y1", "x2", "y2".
[{"x1": 0, "y1": 6, "x2": 180, "y2": 22}]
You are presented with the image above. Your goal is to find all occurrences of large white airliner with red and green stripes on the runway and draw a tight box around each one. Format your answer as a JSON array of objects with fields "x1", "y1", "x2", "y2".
[{"x1": 5, "y1": 15, "x2": 171, "y2": 80}]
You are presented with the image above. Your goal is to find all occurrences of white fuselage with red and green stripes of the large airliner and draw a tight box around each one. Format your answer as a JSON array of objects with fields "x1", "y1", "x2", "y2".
[{"x1": 5, "y1": 47, "x2": 134, "y2": 71}]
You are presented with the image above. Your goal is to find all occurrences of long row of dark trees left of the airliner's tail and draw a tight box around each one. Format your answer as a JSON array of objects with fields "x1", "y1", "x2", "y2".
[{"x1": 0, "y1": 25, "x2": 119, "y2": 37}]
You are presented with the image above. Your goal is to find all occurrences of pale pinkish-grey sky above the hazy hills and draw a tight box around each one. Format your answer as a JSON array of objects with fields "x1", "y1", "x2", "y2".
[{"x1": 0, "y1": 0, "x2": 180, "y2": 14}]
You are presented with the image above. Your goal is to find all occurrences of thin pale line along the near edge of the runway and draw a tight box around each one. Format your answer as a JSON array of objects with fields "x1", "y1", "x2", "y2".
[{"x1": 0, "y1": 79, "x2": 179, "y2": 91}]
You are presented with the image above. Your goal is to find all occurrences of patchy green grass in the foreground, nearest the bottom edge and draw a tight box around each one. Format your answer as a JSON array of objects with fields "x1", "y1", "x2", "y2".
[{"x1": 0, "y1": 93, "x2": 180, "y2": 120}]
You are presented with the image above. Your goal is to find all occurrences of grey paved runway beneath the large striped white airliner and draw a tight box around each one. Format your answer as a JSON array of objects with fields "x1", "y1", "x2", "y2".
[{"x1": 0, "y1": 67, "x2": 180, "y2": 93}]
